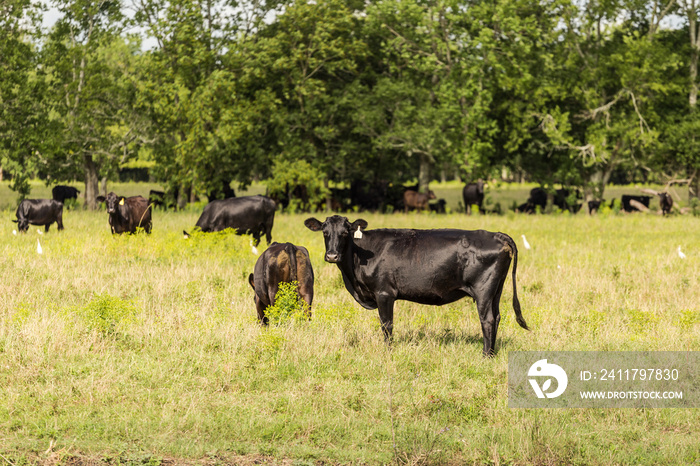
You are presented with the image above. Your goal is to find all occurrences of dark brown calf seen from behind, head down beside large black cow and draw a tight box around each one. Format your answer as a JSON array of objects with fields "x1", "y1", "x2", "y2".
[{"x1": 248, "y1": 243, "x2": 314, "y2": 325}]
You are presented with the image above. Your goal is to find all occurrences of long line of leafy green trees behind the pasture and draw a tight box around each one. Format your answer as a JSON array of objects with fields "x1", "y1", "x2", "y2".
[{"x1": 0, "y1": 0, "x2": 700, "y2": 208}]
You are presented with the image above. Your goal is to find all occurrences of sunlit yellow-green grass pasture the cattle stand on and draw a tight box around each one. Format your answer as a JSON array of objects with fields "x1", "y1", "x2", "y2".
[{"x1": 0, "y1": 181, "x2": 700, "y2": 465}]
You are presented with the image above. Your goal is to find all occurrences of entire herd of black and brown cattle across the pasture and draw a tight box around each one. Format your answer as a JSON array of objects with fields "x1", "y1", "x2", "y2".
[{"x1": 8, "y1": 181, "x2": 673, "y2": 356}]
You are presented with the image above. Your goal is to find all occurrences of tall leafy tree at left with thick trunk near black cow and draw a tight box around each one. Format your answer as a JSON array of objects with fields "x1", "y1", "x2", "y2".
[{"x1": 40, "y1": 0, "x2": 139, "y2": 209}]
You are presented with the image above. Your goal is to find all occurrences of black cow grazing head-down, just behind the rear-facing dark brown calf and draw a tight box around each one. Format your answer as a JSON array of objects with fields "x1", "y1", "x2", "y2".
[{"x1": 194, "y1": 195, "x2": 275, "y2": 246}]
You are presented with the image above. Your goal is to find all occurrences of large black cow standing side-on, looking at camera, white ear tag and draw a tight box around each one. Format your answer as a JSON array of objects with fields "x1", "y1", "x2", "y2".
[{"x1": 304, "y1": 215, "x2": 528, "y2": 356}]
